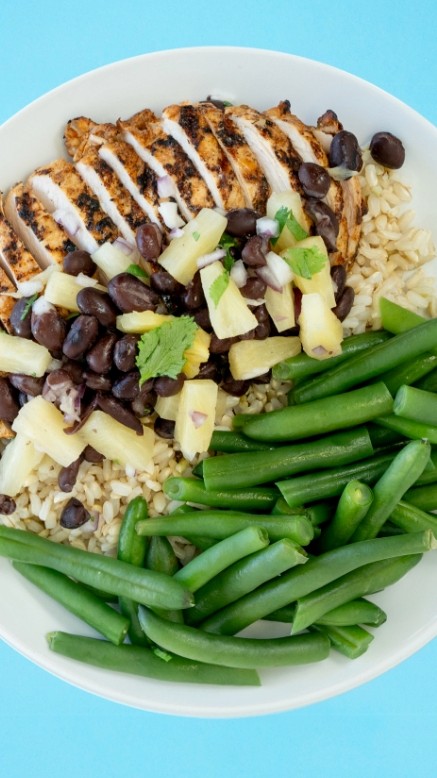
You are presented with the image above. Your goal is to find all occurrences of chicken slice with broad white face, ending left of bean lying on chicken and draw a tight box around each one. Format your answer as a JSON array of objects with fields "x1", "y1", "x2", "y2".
[{"x1": 225, "y1": 105, "x2": 302, "y2": 193}]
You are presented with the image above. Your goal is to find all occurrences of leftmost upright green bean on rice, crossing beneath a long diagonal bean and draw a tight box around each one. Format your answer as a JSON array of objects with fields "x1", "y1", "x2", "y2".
[{"x1": 117, "y1": 497, "x2": 148, "y2": 646}]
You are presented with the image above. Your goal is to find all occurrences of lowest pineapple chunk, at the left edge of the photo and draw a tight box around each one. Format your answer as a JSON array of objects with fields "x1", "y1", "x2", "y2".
[{"x1": 0, "y1": 433, "x2": 44, "y2": 497}]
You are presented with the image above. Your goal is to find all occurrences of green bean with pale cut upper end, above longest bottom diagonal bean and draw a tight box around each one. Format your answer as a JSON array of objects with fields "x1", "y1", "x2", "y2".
[{"x1": 186, "y1": 538, "x2": 308, "y2": 625}]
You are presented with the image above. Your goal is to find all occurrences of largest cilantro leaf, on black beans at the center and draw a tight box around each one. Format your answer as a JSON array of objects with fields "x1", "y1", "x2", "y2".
[{"x1": 136, "y1": 316, "x2": 197, "y2": 386}]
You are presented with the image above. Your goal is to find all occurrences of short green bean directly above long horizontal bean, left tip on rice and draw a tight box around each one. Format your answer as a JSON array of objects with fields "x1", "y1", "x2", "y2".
[{"x1": 163, "y1": 476, "x2": 278, "y2": 511}]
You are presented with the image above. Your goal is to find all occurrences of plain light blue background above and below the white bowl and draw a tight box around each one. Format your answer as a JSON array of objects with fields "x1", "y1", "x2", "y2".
[{"x1": 0, "y1": 0, "x2": 437, "y2": 778}]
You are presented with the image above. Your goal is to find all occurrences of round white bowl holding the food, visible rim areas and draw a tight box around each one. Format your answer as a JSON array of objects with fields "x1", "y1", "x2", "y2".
[{"x1": 0, "y1": 47, "x2": 437, "y2": 717}]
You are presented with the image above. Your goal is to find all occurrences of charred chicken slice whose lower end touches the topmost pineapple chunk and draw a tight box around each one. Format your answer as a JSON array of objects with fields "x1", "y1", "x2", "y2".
[{"x1": 119, "y1": 111, "x2": 214, "y2": 221}]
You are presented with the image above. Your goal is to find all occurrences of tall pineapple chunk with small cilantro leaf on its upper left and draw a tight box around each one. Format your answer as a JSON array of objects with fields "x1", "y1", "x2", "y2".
[{"x1": 200, "y1": 262, "x2": 258, "y2": 339}]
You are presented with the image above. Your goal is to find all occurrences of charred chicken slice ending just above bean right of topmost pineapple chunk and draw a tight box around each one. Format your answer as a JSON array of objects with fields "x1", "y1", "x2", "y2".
[{"x1": 162, "y1": 103, "x2": 244, "y2": 211}]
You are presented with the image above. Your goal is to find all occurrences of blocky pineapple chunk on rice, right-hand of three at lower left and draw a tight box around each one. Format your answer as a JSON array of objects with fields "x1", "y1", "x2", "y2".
[{"x1": 79, "y1": 411, "x2": 155, "y2": 470}]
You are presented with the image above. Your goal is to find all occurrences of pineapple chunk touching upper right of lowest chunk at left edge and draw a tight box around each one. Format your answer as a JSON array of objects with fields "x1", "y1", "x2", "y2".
[{"x1": 12, "y1": 396, "x2": 86, "y2": 467}]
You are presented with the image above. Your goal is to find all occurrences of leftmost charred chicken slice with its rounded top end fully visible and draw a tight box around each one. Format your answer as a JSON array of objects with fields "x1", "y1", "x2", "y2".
[{"x1": 4, "y1": 183, "x2": 76, "y2": 268}]
